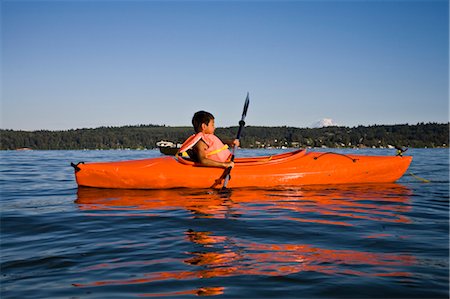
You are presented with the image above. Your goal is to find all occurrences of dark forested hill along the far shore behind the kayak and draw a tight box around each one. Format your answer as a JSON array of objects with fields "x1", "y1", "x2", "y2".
[{"x1": 0, "y1": 123, "x2": 449, "y2": 150}]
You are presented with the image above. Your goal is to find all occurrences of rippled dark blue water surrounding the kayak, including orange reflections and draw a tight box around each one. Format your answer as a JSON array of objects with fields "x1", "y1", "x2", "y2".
[{"x1": 0, "y1": 149, "x2": 449, "y2": 298}]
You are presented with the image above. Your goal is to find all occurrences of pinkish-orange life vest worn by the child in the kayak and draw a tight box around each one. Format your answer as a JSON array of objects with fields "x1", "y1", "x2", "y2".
[{"x1": 178, "y1": 132, "x2": 231, "y2": 162}]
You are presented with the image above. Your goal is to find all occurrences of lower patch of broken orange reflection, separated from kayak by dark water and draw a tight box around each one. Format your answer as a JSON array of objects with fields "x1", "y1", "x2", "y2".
[{"x1": 184, "y1": 231, "x2": 414, "y2": 277}]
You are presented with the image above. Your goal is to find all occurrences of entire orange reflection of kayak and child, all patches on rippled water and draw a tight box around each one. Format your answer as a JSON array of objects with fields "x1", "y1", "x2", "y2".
[{"x1": 74, "y1": 184, "x2": 416, "y2": 297}]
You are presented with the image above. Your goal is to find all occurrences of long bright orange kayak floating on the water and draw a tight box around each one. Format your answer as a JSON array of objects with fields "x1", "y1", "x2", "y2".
[{"x1": 72, "y1": 150, "x2": 412, "y2": 189}]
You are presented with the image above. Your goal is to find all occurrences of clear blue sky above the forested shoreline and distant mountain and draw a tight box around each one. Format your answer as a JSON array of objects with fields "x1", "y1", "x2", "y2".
[{"x1": 0, "y1": 0, "x2": 449, "y2": 131}]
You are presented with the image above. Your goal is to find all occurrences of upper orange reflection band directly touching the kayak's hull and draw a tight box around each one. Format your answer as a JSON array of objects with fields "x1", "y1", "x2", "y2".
[{"x1": 76, "y1": 184, "x2": 411, "y2": 226}]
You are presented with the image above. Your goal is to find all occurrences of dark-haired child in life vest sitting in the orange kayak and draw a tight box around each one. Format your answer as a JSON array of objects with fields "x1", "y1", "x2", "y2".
[{"x1": 178, "y1": 111, "x2": 239, "y2": 168}]
